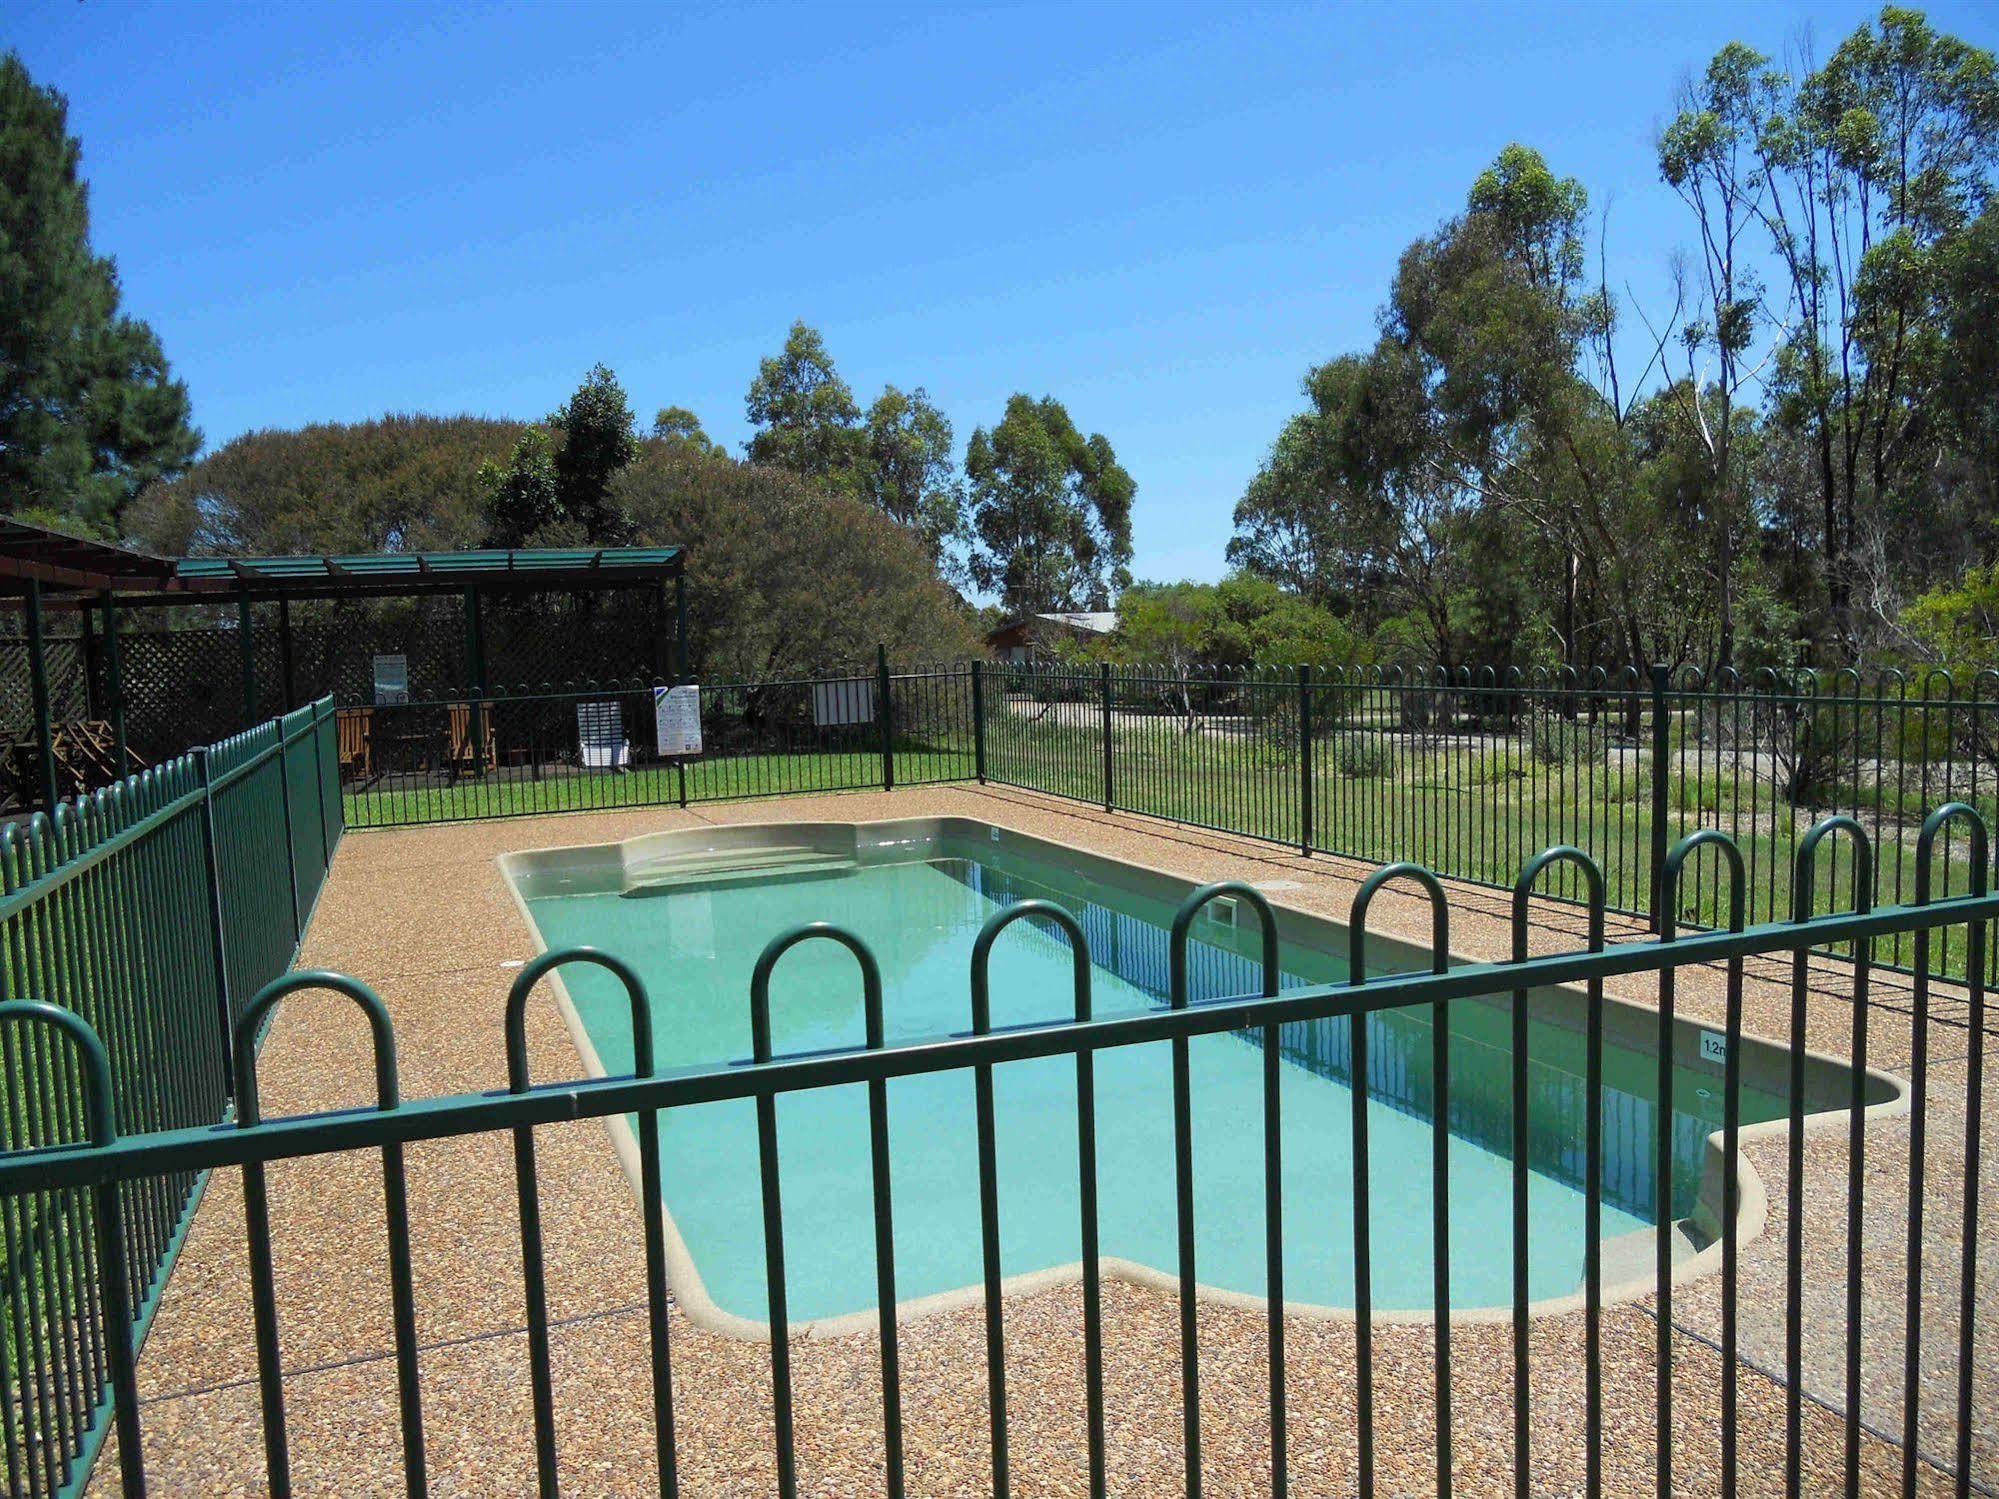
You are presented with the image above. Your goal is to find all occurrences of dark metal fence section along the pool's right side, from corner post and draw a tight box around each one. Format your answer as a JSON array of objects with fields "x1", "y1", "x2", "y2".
[{"x1": 978, "y1": 666, "x2": 1999, "y2": 987}]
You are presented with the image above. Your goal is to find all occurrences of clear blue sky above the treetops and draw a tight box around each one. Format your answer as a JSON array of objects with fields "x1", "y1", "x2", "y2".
[{"x1": 0, "y1": 0, "x2": 1999, "y2": 578}]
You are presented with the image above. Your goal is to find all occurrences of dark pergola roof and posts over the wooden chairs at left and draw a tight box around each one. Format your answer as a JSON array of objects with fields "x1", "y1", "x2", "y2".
[{"x1": 0, "y1": 520, "x2": 688, "y2": 807}]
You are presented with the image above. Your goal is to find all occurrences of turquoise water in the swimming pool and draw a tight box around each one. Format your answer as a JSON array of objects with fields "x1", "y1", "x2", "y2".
[{"x1": 528, "y1": 841, "x2": 1783, "y2": 1321}]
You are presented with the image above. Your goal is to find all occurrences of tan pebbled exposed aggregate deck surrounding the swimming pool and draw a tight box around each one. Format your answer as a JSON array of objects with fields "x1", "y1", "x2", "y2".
[{"x1": 94, "y1": 787, "x2": 1999, "y2": 1495}]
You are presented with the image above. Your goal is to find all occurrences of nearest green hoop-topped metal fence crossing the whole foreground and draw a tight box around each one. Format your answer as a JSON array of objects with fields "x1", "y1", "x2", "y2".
[{"x1": 0, "y1": 815, "x2": 1999, "y2": 1499}]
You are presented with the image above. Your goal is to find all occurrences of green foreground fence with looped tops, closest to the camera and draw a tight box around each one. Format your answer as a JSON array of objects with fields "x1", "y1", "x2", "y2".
[{"x1": 0, "y1": 807, "x2": 1999, "y2": 1493}]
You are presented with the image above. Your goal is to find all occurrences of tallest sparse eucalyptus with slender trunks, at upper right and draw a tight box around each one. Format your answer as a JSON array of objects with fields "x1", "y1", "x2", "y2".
[{"x1": 1663, "y1": 6, "x2": 1999, "y2": 650}]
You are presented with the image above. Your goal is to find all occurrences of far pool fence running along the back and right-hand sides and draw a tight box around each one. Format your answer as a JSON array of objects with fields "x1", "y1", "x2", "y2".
[{"x1": 340, "y1": 656, "x2": 1999, "y2": 979}]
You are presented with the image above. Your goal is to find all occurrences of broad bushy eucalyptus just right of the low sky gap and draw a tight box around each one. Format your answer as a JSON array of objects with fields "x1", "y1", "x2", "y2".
[{"x1": 1229, "y1": 144, "x2": 1733, "y2": 662}]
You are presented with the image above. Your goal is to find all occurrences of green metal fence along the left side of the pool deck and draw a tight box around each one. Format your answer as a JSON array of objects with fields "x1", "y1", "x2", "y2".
[{"x1": 0, "y1": 698, "x2": 342, "y2": 1495}]
